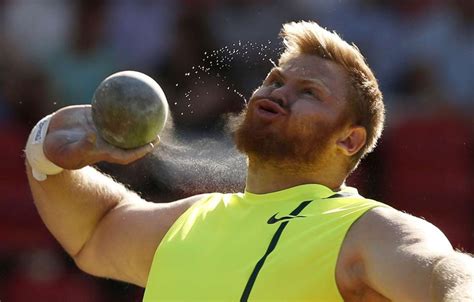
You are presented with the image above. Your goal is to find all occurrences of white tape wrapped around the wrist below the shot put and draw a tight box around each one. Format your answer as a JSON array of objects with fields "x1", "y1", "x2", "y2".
[{"x1": 25, "y1": 114, "x2": 63, "y2": 181}]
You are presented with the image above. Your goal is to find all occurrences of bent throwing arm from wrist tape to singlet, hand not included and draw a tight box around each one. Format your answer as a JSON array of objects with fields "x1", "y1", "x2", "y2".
[{"x1": 27, "y1": 167, "x2": 202, "y2": 287}]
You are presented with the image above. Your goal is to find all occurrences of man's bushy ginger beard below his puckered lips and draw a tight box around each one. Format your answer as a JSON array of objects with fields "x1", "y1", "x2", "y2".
[{"x1": 233, "y1": 102, "x2": 345, "y2": 170}]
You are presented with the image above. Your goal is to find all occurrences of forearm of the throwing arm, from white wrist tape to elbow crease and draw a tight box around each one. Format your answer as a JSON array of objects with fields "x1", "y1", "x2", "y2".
[{"x1": 27, "y1": 163, "x2": 134, "y2": 257}]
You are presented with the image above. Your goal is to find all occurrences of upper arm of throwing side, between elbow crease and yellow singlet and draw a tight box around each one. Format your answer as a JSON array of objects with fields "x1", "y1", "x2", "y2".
[{"x1": 75, "y1": 195, "x2": 206, "y2": 287}]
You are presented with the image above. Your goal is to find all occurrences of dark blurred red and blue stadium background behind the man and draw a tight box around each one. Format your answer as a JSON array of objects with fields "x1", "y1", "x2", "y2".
[{"x1": 0, "y1": 0, "x2": 474, "y2": 302}]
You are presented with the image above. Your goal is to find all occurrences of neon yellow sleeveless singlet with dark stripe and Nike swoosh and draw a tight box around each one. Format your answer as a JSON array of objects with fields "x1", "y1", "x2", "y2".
[{"x1": 144, "y1": 184, "x2": 383, "y2": 302}]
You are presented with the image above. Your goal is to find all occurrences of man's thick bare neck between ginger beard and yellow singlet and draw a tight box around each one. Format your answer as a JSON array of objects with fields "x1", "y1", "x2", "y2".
[{"x1": 246, "y1": 158, "x2": 345, "y2": 194}]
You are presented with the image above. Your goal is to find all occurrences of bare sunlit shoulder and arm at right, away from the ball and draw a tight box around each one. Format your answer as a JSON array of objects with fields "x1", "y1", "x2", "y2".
[{"x1": 340, "y1": 208, "x2": 474, "y2": 301}]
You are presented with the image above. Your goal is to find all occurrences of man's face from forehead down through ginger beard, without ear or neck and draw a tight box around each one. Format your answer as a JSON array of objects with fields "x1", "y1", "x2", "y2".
[{"x1": 235, "y1": 55, "x2": 348, "y2": 168}]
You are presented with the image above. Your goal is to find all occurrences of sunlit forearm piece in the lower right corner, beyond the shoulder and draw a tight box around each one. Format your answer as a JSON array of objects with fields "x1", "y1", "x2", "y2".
[{"x1": 431, "y1": 253, "x2": 474, "y2": 302}]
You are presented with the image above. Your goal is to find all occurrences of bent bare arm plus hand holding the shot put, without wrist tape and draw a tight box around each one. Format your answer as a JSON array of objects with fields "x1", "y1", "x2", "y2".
[{"x1": 26, "y1": 106, "x2": 207, "y2": 286}]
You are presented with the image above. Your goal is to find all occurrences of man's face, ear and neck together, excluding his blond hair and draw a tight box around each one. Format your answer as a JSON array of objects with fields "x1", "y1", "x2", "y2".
[{"x1": 237, "y1": 55, "x2": 366, "y2": 193}]
